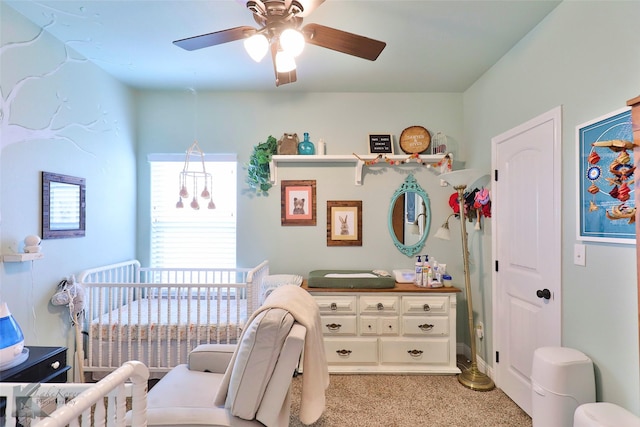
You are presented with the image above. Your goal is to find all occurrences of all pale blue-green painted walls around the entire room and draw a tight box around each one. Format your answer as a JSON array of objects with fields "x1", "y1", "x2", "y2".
[{"x1": 0, "y1": 2, "x2": 640, "y2": 414}]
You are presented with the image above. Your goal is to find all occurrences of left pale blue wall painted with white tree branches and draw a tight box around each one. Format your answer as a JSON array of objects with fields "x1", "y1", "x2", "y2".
[{"x1": 0, "y1": 3, "x2": 136, "y2": 352}]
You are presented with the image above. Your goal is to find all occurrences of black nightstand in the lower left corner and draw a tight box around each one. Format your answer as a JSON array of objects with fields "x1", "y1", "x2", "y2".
[{"x1": 0, "y1": 346, "x2": 71, "y2": 383}]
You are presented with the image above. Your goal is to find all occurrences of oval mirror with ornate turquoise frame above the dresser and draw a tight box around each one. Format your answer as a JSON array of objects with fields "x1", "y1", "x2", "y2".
[{"x1": 389, "y1": 174, "x2": 431, "y2": 256}]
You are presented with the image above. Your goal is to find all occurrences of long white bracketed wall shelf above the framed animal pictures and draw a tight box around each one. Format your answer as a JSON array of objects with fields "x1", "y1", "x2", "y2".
[{"x1": 269, "y1": 154, "x2": 445, "y2": 185}]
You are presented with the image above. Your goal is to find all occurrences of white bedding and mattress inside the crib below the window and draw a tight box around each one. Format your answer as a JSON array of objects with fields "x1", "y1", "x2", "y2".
[{"x1": 89, "y1": 298, "x2": 247, "y2": 341}]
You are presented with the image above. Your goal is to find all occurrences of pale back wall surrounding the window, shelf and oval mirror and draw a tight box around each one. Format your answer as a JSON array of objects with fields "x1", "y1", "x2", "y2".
[{"x1": 138, "y1": 90, "x2": 462, "y2": 277}]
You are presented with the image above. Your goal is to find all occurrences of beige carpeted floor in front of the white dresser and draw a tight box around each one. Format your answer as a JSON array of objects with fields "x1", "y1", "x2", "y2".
[{"x1": 289, "y1": 360, "x2": 531, "y2": 427}]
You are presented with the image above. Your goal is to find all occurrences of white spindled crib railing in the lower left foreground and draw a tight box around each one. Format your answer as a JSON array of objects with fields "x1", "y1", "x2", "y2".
[{"x1": 2, "y1": 360, "x2": 149, "y2": 427}]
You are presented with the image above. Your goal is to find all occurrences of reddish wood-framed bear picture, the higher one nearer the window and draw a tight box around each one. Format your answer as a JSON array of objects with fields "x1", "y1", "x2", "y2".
[{"x1": 280, "y1": 180, "x2": 316, "y2": 225}]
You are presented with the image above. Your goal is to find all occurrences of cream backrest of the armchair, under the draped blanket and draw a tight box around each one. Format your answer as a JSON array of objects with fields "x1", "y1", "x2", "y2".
[{"x1": 225, "y1": 308, "x2": 294, "y2": 420}]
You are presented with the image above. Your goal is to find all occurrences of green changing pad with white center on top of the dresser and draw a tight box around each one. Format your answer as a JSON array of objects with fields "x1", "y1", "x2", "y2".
[{"x1": 307, "y1": 270, "x2": 396, "y2": 289}]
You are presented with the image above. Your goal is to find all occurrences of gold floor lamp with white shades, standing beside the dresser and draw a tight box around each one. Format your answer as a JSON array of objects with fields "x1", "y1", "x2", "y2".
[{"x1": 435, "y1": 169, "x2": 495, "y2": 391}]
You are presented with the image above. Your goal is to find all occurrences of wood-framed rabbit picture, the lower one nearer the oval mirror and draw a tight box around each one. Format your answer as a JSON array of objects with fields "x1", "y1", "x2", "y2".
[{"x1": 327, "y1": 200, "x2": 362, "y2": 246}]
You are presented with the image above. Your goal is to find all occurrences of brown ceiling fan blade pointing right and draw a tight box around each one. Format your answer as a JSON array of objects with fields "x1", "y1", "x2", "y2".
[{"x1": 302, "y1": 24, "x2": 387, "y2": 61}]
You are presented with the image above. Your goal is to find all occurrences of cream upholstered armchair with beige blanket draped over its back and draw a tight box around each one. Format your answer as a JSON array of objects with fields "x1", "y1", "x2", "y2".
[{"x1": 131, "y1": 286, "x2": 329, "y2": 427}]
